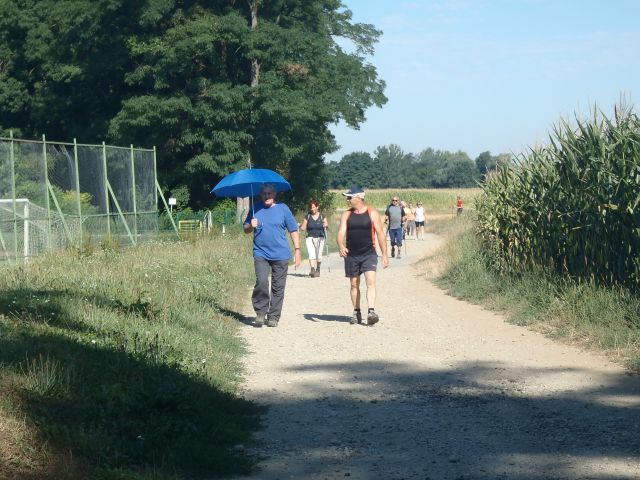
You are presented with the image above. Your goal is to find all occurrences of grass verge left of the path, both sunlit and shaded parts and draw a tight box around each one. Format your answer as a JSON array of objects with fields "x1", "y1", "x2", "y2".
[{"x1": 0, "y1": 232, "x2": 259, "y2": 480}]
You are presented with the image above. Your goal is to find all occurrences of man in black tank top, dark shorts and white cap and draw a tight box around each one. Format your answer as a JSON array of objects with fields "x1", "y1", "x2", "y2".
[{"x1": 338, "y1": 187, "x2": 389, "y2": 325}]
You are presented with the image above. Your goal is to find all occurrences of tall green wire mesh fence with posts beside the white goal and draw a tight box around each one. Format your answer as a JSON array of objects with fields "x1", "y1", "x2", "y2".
[{"x1": 0, "y1": 138, "x2": 158, "y2": 261}]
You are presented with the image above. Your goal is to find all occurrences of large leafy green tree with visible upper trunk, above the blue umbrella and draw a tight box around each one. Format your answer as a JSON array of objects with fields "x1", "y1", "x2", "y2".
[{"x1": 112, "y1": 0, "x2": 386, "y2": 209}]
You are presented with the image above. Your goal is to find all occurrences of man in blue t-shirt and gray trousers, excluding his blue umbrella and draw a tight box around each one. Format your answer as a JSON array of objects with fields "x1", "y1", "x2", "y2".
[{"x1": 243, "y1": 183, "x2": 301, "y2": 327}]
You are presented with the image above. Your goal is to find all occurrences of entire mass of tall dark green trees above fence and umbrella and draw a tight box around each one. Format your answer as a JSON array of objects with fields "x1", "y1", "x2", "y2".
[{"x1": 0, "y1": 0, "x2": 386, "y2": 206}]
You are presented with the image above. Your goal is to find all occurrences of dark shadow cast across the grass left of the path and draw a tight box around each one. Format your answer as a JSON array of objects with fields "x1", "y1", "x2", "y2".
[{"x1": 0, "y1": 290, "x2": 262, "y2": 479}]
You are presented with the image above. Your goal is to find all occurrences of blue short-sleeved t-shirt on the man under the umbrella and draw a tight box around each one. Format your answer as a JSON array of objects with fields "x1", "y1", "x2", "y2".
[{"x1": 244, "y1": 203, "x2": 298, "y2": 260}]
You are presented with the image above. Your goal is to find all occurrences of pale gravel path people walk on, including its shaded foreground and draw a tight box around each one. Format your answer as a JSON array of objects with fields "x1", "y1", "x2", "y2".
[{"x1": 238, "y1": 235, "x2": 640, "y2": 480}]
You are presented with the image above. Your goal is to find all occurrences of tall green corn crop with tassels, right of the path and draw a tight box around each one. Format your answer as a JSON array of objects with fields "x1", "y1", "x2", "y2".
[{"x1": 476, "y1": 107, "x2": 640, "y2": 291}]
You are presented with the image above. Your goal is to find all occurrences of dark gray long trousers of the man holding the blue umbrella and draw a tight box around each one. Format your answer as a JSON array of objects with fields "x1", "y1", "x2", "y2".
[{"x1": 251, "y1": 257, "x2": 289, "y2": 320}]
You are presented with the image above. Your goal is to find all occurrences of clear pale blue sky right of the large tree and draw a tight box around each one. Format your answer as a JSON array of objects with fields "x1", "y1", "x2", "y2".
[{"x1": 327, "y1": 0, "x2": 640, "y2": 160}]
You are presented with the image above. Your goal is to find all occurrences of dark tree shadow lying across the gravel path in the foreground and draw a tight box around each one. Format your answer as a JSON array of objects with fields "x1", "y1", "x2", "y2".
[{"x1": 241, "y1": 360, "x2": 640, "y2": 480}]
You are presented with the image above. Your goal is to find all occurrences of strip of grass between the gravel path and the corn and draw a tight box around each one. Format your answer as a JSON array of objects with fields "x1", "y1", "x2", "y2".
[{"x1": 433, "y1": 216, "x2": 640, "y2": 372}]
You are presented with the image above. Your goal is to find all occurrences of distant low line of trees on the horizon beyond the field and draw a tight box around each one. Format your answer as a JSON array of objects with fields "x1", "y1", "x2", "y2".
[{"x1": 327, "y1": 145, "x2": 512, "y2": 188}]
